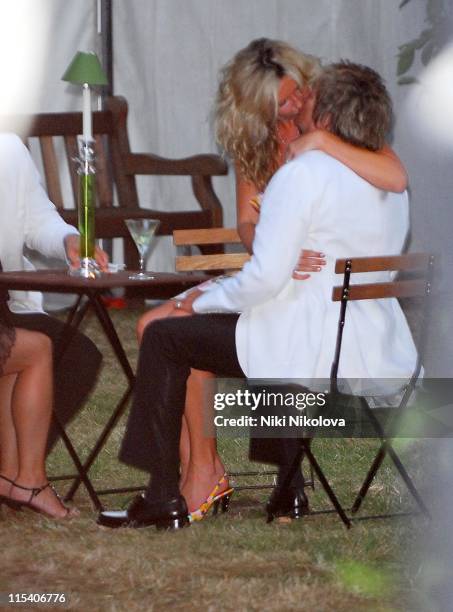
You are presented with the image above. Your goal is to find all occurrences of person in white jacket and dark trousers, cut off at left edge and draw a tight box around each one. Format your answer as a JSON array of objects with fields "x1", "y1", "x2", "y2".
[{"x1": 0, "y1": 134, "x2": 107, "y2": 449}]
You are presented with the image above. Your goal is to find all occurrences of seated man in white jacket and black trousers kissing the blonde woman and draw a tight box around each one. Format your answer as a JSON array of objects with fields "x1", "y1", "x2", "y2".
[{"x1": 99, "y1": 63, "x2": 416, "y2": 528}]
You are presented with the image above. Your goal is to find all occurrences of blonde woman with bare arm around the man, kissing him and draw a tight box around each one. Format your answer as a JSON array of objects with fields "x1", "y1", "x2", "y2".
[{"x1": 137, "y1": 38, "x2": 407, "y2": 519}]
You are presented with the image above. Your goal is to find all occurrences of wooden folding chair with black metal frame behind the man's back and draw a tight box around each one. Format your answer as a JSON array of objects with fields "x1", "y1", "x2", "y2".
[{"x1": 331, "y1": 253, "x2": 434, "y2": 517}]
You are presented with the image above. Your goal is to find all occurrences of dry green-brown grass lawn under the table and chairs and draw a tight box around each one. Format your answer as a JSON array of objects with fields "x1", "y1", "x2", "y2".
[{"x1": 0, "y1": 311, "x2": 424, "y2": 612}]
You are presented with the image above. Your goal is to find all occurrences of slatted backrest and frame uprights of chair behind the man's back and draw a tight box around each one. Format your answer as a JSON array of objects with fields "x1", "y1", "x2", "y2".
[{"x1": 331, "y1": 253, "x2": 434, "y2": 386}]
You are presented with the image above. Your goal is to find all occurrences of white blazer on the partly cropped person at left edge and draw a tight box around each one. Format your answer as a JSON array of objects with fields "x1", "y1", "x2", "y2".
[{"x1": 0, "y1": 134, "x2": 78, "y2": 312}]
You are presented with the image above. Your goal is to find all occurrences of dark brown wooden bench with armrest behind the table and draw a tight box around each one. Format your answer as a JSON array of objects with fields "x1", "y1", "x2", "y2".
[{"x1": 18, "y1": 96, "x2": 228, "y2": 297}]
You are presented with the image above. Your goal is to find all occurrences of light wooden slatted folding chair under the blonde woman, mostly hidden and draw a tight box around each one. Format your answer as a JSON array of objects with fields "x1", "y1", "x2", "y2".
[{"x1": 173, "y1": 227, "x2": 314, "y2": 490}]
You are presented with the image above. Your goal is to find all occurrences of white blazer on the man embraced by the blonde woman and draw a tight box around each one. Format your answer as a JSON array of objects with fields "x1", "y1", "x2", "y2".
[{"x1": 194, "y1": 151, "x2": 416, "y2": 388}]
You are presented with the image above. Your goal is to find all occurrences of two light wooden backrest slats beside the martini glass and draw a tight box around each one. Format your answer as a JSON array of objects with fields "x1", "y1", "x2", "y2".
[{"x1": 173, "y1": 227, "x2": 250, "y2": 272}]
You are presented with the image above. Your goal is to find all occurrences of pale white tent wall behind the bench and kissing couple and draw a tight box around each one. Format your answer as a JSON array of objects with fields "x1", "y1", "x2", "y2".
[{"x1": 0, "y1": 0, "x2": 453, "y2": 370}]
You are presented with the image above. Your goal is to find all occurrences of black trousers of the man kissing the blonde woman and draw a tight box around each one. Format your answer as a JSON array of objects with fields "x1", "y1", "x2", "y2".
[{"x1": 120, "y1": 314, "x2": 303, "y2": 501}]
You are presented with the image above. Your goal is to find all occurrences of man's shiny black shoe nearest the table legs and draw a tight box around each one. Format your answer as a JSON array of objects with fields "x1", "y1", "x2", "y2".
[{"x1": 97, "y1": 493, "x2": 190, "y2": 529}]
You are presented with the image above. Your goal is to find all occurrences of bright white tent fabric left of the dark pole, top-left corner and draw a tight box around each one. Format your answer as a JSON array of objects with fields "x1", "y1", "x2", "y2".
[{"x1": 0, "y1": 0, "x2": 98, "y2": 114}]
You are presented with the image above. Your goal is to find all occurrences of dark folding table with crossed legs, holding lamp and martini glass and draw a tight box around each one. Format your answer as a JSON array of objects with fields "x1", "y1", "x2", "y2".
[{"x1": 0, "y1": 270, "x2": 208, "y2": 510}]
